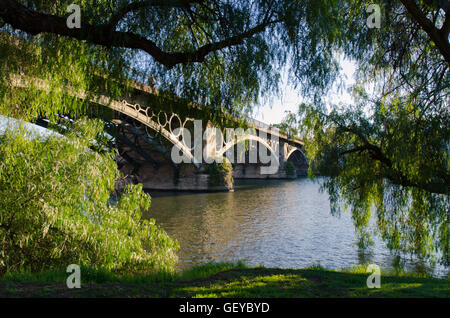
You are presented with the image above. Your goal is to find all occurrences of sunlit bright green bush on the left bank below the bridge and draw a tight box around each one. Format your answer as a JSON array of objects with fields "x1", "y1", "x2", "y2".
[{"x1": 0, "y1": 121, "x2": 178, "y2": 273}]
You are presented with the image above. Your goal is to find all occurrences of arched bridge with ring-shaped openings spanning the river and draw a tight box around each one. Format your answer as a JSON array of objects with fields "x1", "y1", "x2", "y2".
[{"x1": 11, "y1": 76, "x2": 308, "y2": 191}]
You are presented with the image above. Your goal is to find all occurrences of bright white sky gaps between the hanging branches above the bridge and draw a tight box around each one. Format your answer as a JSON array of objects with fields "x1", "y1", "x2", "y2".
[{"x1": 252, "y1": 60, "x2": 356, "y2": 124}]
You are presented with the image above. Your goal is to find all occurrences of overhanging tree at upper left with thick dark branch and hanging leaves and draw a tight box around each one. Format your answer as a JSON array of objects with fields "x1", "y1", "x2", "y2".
[{"x1": 0, "y1": 0, "x2": 352, "y2": 117}]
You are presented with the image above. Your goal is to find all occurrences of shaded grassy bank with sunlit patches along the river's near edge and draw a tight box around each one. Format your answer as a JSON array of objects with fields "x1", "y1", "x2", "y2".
[{"x1": 0, "y1": 264, "x2": 450, "y2": 298}]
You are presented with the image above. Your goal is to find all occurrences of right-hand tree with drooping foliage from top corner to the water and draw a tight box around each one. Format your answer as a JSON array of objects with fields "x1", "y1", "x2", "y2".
[{"x1": 300, "y1": 1, "x2": 450, "y2": 264}]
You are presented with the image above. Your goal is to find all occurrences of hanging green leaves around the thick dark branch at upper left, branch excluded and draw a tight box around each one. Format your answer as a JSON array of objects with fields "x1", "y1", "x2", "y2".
[{"x1": 0, "y1": 0, "x2": 356, "y2": 118}]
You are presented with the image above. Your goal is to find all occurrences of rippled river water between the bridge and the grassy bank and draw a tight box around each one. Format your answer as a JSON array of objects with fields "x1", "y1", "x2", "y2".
[{"x1": 145, "y1": 179, "x2": 448, "y2": 277}]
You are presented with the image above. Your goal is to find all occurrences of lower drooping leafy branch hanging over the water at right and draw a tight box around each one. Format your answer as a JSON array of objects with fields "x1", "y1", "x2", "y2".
[{"x1": 304, "y1": 97, "x2": 450, "y2": 264}]
